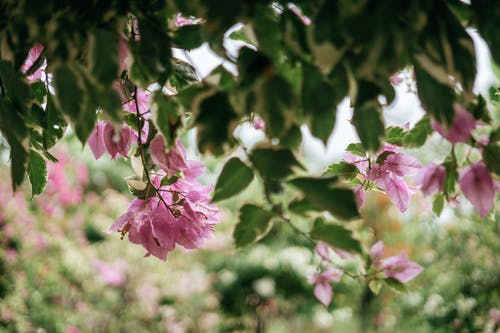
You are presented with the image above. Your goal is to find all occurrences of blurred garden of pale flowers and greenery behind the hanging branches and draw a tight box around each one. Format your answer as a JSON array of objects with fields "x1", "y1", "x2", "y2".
[{"x1": 0, "y1": 125, "x2": 500, "y2": 333}]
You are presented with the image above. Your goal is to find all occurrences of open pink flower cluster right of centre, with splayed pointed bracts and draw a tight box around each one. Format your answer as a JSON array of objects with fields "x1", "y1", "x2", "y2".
[{"x1": 344, "y1": 144, "x2": 421, "y2": 212}]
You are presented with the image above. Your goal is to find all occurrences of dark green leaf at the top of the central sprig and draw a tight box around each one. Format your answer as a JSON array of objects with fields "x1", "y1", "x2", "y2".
[{"x1": 249, "y1": 146, "x2": 304, "y2": 179}]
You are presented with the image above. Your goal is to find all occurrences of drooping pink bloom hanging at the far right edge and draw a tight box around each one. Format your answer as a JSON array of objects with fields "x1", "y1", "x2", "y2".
[{"x1": 460, "y1": 162, "x2": 495, "y2": 217}]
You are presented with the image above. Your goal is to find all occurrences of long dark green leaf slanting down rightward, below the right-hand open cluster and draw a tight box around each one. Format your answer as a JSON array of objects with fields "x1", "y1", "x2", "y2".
[{"x1": 290, "y1": 177, "x2": 359, "y2": 220}]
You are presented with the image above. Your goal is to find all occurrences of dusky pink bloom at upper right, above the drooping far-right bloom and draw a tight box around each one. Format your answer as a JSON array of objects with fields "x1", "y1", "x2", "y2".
[{"x1": 431, "y1": 103, "x2": 477, "y2": 144}]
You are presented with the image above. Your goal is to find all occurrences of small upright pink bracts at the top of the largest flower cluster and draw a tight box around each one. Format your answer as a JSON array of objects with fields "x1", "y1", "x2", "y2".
[{"x1": 149, "y1": 134, "x2": 190, "y2": 177}]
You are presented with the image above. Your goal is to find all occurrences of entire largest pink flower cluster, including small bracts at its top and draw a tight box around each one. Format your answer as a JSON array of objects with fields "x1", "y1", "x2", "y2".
[{"x1": 108, "y1": 135, "x2": 220, "y2": 260}]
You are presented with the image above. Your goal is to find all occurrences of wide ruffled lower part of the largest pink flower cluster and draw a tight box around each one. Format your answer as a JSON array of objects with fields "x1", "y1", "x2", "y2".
[{"x1": 108, "y1": 164, "x2": 220, "y2": 260}]
